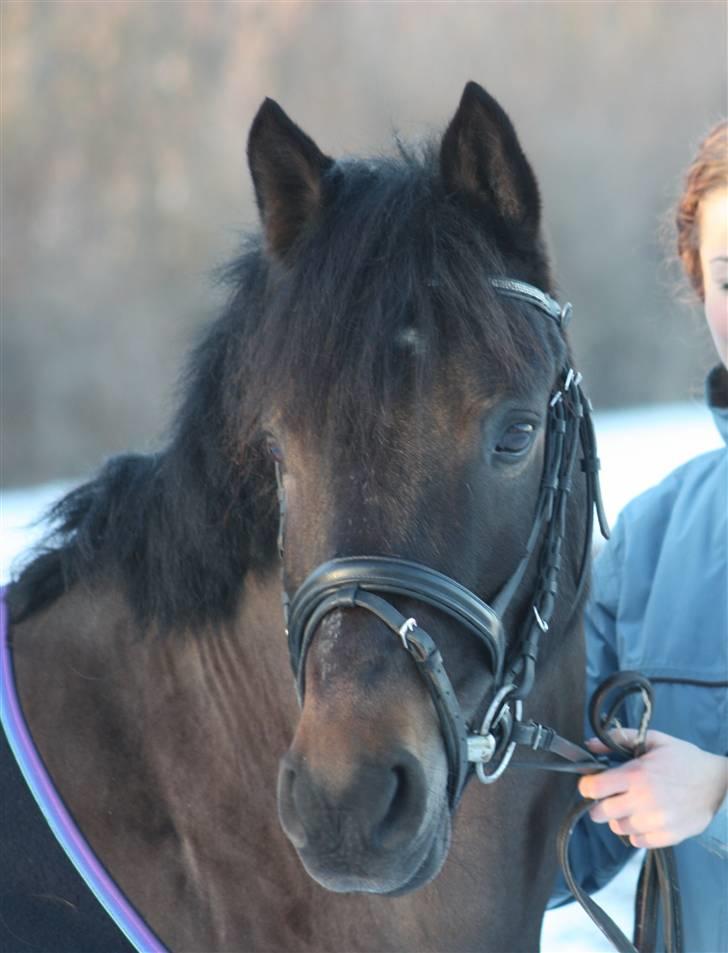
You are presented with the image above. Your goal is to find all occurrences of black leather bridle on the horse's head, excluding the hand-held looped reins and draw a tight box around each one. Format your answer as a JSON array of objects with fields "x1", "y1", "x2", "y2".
[{"x1": 277, "y1": 278, "x2": 608, "y2": 808}]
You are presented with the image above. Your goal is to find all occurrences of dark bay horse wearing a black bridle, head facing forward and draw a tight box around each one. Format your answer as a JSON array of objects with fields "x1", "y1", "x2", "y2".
[{"x1": 8, "y1": 83, "x2": 585, "y2": 953}]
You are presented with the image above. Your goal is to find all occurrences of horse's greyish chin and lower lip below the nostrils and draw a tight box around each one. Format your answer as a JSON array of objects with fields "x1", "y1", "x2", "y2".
[{"x1": 299, "y1": 809, "x2": 452, "y2": 897}]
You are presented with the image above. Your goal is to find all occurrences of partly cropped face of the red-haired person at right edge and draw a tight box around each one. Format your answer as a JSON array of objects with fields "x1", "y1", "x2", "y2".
[{"x1": 698, "y1": 187, "x2": 728, "y2": 367}]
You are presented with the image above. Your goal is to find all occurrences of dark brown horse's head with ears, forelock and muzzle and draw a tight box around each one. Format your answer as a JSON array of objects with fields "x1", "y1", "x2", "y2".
[{"x1": 239, "y1": 83, "x2": 583, "y2": 894}]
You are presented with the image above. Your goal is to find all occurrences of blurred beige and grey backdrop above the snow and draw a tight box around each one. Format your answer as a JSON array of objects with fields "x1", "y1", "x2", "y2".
[{"x1": 0, "y1": 0, "x2": 728, "y2": 487}]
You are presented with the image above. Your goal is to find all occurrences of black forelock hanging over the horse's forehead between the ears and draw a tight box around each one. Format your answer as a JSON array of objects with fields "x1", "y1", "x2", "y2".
[{"x1": 228, "y1": 147, "x2": 559, "y2": 451}]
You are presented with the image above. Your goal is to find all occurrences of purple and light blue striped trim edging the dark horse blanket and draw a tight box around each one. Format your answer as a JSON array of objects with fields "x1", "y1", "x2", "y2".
[{"x1": 0, "y1": 588, "x2": 166, "y2": 953}]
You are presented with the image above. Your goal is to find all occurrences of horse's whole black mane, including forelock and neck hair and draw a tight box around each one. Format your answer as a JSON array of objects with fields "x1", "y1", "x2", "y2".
[{"x1": 9, "y1": 141, "x2": 561, "y2": 628}]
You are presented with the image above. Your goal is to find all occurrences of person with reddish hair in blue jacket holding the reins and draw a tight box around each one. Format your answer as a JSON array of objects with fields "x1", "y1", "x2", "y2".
[{"x1": 552, "y1": 122, "x2": 728, "y2": 953}]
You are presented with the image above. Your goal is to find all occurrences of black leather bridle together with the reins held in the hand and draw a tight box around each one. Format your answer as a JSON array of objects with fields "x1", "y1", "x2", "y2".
[{"x1": 276, "y1": 278, "x2": 682, "y2": 953}]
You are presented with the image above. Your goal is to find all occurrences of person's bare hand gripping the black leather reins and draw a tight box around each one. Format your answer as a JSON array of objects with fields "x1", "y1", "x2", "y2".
[{"x1": 579, "y1": 728, "x2": 728, "y2": 848}]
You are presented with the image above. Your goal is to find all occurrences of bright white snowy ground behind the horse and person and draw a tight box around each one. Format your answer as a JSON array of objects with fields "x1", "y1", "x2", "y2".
[{"x1": 0, "y1": 403, "x2": 723, "y2": 953}]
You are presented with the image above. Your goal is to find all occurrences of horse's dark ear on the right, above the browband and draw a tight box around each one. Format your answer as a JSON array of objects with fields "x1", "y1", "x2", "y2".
[{"x1": 440, "y1": 82, "x2": 541, "y2": 233}]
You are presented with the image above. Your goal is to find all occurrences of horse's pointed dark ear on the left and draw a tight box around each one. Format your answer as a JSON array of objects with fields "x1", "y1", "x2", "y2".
[{"x1": 248, "y1": 99, "x2": 333, "y2": 256}]
